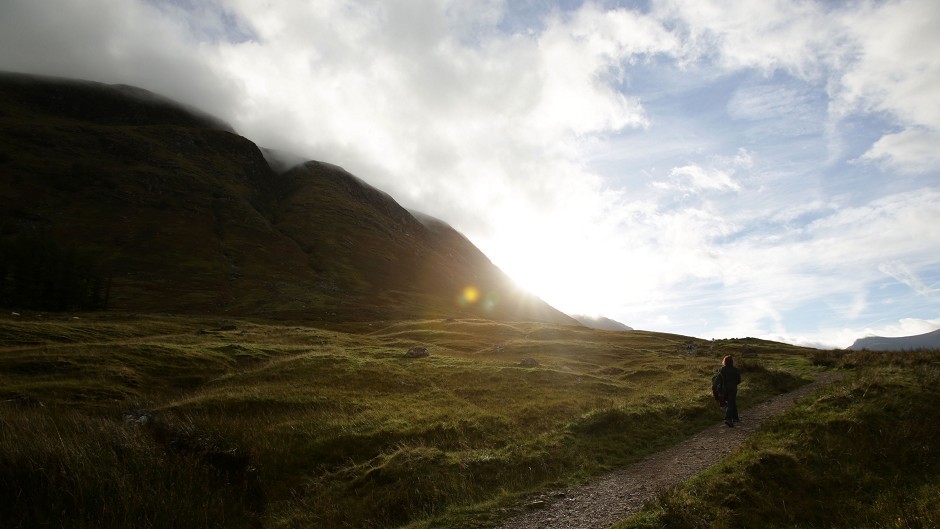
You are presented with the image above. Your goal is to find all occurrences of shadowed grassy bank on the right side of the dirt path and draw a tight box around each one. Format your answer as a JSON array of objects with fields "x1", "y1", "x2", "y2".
[{"x1": 616, "y1": 351, "x2": 940, "y2": 529}]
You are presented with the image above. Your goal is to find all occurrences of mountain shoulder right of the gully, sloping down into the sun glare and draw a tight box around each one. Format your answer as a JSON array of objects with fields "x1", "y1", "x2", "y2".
[{"x1": 277, "y1": 162, "x2": 577, "y2": 325}]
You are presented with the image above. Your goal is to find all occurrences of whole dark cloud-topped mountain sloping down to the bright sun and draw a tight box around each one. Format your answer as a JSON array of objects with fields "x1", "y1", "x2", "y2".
[{"x1": 0, "y1": 73, "x2": 577, "y2": 325}]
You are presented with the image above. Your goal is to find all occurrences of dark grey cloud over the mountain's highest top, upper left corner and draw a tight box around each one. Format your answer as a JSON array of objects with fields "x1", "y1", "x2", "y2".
[{"x1": 0, "y1": 0, "x2": 246, "y2": 118}]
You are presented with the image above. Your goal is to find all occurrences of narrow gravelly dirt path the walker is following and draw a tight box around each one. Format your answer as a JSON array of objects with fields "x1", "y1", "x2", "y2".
[{"x1": 501, "y1": 373, "x2": 842, "y2": 529}]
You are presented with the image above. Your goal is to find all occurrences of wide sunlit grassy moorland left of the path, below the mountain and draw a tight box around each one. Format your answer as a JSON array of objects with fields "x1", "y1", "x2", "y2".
[{"x1": 0, "y1": 314, "x2": 809, "y2": 527}]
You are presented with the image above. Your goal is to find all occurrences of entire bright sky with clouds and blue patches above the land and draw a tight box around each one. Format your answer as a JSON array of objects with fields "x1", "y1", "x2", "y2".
[{"x1": 0, "y1": 0, "x2": 940, "y2": 348}]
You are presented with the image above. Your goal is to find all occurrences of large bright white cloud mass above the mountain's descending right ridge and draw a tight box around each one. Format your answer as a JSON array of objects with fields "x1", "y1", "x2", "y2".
[{"x1": 207, "y1": 0, "x2": 675, "y2": 228}]
